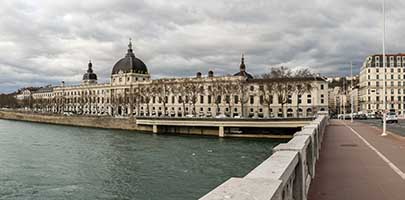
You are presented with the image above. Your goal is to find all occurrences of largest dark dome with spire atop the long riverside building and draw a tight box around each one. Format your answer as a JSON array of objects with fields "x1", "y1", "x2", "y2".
[{"x1": 111, "y1": 41, "x2": 148, "y2": 74}]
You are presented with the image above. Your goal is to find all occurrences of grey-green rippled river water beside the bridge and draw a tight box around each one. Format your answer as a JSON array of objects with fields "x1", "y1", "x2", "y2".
[{"x1": 0, "y1": 120, "x2": 283, "y2": 200}]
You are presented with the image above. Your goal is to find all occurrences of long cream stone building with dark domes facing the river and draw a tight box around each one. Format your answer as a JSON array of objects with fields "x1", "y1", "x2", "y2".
[{"x1": 21, "y1": 42, "x2": 328, "y2": 118}]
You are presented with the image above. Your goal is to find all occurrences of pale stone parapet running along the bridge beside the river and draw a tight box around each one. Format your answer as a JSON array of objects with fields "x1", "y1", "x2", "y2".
[{"x1": 200, "y1": 113, "x2": 329, "y2": 200}]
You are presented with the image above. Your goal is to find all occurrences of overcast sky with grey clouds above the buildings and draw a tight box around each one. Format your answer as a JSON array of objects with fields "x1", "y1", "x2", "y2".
[{"x1": 0, "y1": 0, "x2": 405, "y2": 93}]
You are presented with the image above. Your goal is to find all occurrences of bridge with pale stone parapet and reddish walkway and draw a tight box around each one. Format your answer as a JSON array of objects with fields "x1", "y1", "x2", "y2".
[{"x1": 201, "y1": 116, "x2": 405, "y2": 200}]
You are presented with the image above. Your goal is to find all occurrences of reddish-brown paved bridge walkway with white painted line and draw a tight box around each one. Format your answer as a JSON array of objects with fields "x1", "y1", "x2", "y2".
[{"x1": 308, "y1": 120, "x2": 405, "y2": 200}]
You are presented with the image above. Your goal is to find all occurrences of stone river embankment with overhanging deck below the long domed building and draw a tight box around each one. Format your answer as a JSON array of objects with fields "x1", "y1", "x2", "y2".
[{"x1": 0, "y1": 110, "x2": 304, "y2": 139}]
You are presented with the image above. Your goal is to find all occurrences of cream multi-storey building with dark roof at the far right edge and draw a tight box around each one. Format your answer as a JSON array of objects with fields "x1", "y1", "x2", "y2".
[{"x1": 359, "y1": 54, "x2": 405, "y2": 115}]
